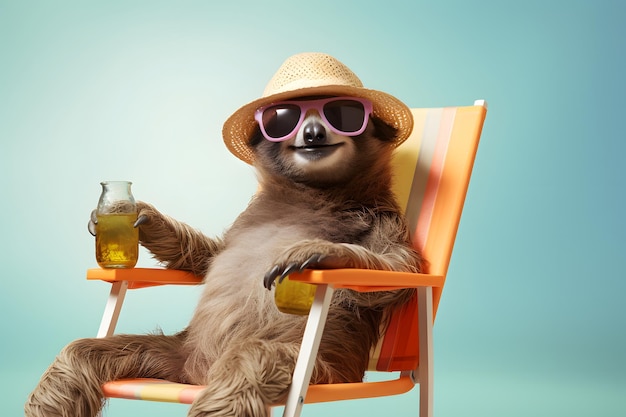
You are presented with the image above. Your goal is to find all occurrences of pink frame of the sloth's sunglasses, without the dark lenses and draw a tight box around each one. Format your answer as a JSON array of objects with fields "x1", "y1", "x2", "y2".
[{"x1": 254, "y1": 96, "x2": 373, "y2": 142}]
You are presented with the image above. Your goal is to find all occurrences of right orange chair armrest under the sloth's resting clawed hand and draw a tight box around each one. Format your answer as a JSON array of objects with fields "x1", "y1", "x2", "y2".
[{"x1": 289, "y1": 268, "x2": 445, "y2": 292}]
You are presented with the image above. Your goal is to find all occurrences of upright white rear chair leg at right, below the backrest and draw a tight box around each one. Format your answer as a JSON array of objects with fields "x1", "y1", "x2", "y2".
[{"x1": 417, "y1": 287, "x2": 433, "y2": 417}]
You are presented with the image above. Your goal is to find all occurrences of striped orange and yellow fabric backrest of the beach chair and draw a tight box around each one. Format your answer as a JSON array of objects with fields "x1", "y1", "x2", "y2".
[{"x1": 370, "y1": 100, "x2": 487, "y2": 371}]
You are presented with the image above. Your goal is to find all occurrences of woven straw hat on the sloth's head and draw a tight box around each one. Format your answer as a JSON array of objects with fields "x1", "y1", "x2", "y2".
[{"x1": 222, "y1": 53, "x2": 413, "y2": 164}]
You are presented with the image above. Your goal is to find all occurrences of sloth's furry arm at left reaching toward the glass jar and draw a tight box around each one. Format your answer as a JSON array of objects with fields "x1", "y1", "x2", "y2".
[{"x1": 137, "y1": 201, "x2": 224, "y2": 276}]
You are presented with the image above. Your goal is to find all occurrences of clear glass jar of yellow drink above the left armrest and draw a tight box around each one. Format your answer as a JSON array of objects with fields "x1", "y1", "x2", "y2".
[{"x1": 96, "y1": 181, "x2": 139, "y2": 268}]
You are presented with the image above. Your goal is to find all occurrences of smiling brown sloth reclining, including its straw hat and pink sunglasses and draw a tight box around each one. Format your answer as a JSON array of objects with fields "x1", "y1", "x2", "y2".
[{"x1": 25, "y1": 53, "x2": 424, "y2": 417}]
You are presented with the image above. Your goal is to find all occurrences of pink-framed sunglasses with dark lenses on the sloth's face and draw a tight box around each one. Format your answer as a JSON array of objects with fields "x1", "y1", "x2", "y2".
[{"x1": 254, "y1": 97, "x2": 372, "y2": 142}]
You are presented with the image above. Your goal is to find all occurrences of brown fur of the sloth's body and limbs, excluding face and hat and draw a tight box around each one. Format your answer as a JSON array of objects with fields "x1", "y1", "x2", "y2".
[{"x1": 25, "y1": 111, "x2": 422, "y2": 417}]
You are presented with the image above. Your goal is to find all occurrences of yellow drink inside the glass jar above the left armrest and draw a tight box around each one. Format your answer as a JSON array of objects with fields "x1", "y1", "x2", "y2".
[{"x1": 96, "y1": 213, "x2": 139, "y2": 268}]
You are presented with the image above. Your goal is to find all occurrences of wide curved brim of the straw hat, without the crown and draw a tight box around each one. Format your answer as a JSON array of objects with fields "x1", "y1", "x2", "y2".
[{"x1": 222, "y1": 85, "x2": 413, "y2": 164}]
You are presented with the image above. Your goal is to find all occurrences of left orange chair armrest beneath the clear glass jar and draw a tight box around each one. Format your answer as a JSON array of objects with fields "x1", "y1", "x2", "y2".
[{"x1": 87, "y1": 268, "x2": 203, "y2": 289}]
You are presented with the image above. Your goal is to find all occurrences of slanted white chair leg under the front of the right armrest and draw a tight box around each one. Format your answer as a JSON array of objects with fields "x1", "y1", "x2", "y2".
[{"x1": 283, "y1": 285, "x2": 333, "y2": 417}]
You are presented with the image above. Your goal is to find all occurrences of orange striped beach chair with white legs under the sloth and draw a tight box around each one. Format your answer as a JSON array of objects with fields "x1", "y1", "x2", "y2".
[{"x1": 87, "y1": 100, "x2": 487, "y2": 417}]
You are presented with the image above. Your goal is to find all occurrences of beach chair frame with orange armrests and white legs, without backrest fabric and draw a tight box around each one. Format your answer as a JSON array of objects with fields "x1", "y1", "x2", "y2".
[{"x1": 87, "y1": 100, "x2": 487, "y2": 417}]
